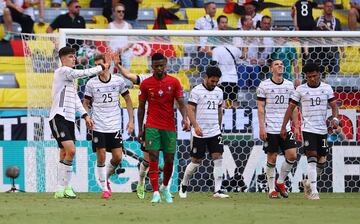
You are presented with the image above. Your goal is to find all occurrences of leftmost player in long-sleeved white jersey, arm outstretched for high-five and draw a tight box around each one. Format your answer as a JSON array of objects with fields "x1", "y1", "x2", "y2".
[{"x1": 49, "y1": 47, "x2": 109, "y2": 198}]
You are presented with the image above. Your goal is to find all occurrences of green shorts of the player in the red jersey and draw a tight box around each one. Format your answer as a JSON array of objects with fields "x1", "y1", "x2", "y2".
[{"x1": 145, "y1": 128, "x2": 176, "y2": 154}]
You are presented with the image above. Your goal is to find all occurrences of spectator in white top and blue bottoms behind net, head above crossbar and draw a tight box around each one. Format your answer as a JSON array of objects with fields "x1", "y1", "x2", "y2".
[{"x1": 234, "y1": 15, "x2": 260, "y2": 91}]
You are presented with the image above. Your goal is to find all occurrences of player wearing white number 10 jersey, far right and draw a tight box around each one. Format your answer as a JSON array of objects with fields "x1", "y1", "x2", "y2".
[{"x1": 280, "y1": 62, "x2": 339, "y2": 200}]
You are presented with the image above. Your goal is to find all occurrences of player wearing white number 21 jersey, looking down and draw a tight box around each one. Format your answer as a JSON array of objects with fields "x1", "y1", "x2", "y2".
[{"x1": 179, "y1": 66, "x2": 229, "y2": 198}]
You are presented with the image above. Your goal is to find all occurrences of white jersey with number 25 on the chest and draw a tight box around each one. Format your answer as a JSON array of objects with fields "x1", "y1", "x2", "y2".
[{"x1": 85, "y1": 75, "x2": 129, "y2": 133}]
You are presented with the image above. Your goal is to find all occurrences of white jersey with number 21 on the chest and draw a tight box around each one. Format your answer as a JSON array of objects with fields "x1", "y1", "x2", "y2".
[{"x1": 188, "y1": 84, "x2": 223, "y2": 138}]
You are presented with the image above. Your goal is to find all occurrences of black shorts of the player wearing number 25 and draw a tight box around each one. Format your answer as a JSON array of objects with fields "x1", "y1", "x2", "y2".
[{"x1": 92, "y1": 131, "x2": 123, "y2": 152}]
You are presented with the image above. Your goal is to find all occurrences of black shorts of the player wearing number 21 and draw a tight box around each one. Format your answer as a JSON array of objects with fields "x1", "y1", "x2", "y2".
[{"x1": 190, "y1": 134, "x2": 224, "y2": 159}]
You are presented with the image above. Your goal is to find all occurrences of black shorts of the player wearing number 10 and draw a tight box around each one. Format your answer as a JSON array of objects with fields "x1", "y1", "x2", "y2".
[{"x1": 303, "y1": 131, "x2": 330, "y2": 156}]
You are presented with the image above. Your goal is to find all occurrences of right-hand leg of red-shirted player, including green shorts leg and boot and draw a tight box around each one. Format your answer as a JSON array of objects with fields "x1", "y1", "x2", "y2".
[{"x1": 160, "y1": 130, "x2": 176, "y2": 203}]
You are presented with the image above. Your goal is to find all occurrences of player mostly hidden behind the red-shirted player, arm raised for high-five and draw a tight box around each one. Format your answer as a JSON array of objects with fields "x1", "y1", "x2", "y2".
[{"x1": 114, "y1": 58, "x2": 151, "y2": 199}]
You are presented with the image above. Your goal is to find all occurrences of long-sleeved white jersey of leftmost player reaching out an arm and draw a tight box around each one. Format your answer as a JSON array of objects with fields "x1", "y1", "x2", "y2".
[{"x1": 48, "y1": 65, "x2": 102, "y2": 122}]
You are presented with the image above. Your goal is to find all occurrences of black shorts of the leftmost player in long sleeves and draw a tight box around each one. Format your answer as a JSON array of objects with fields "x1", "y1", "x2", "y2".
[{"x1": 49, "y1": 114, "x2": 75, "y2": 148}]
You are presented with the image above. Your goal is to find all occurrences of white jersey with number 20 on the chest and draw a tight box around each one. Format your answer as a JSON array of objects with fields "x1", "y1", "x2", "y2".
[{"x1": 256, "y1": 79, "x2": 294, "y2": 134}]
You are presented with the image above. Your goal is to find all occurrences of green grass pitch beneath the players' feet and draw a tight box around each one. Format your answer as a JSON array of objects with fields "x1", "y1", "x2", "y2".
[{"x1": 0, "y1": 193, "x2": 360, "y2": 224}]
